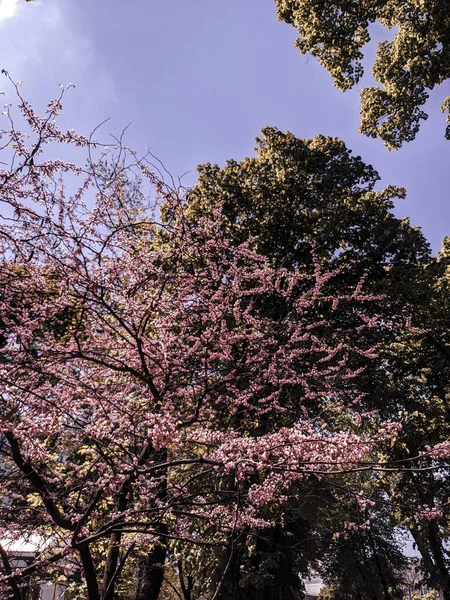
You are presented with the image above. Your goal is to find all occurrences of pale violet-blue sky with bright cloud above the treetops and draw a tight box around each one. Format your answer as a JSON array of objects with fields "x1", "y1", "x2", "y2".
[{"x1": 0, "y1": 0, "x2": 450, "y2": 250}]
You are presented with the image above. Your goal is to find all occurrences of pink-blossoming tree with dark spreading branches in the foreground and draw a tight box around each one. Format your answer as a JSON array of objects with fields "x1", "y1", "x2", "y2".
[{"x1": 0, "y1": 81, "x2": 418, "y2": 600}]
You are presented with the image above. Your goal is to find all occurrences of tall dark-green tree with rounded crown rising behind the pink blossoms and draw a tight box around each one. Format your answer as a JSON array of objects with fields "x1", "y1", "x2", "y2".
[{"x1": 182, "y1": 127, "x2": 436, "y2": 600}]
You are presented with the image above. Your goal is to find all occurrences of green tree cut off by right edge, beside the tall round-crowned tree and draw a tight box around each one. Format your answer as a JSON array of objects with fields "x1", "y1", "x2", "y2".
[{"x1": 374, "y1": 238, "x2": 450, "y2": 597}]
